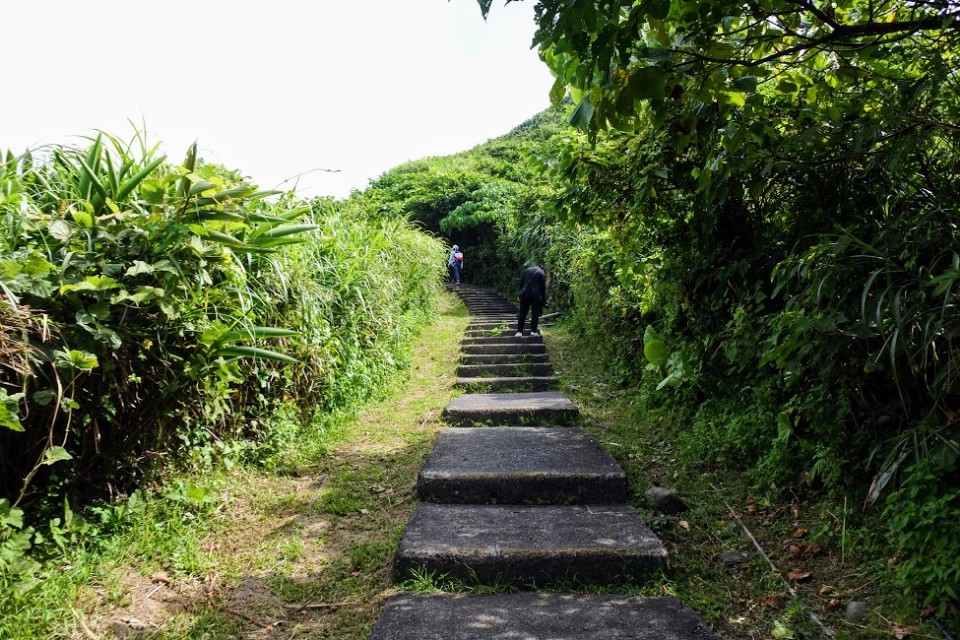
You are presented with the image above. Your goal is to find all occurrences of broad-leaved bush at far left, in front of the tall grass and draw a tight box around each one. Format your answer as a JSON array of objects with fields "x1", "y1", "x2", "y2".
[{"x1": 0, "y1": 136, "x2": 312, "y2": 502}]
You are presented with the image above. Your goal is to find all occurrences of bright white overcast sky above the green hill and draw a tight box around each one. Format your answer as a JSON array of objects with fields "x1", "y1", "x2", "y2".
[{"x1": 0, "y1": 0, "x2": 552, "y2": 197}]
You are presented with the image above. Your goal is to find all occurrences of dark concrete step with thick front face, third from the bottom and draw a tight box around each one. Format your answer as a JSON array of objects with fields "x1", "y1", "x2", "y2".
[{"x1": 417, "y1": 427, "x2": 627, "y2": 504}]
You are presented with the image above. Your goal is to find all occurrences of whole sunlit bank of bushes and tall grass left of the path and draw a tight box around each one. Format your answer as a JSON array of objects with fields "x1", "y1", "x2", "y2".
[{"x1": 0, "y1": 135, "x2": 444, "y2": 620}]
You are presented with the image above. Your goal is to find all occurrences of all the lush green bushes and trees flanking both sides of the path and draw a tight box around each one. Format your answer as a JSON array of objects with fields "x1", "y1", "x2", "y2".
[{"x1": 0, "y1": 0, "x2": 960, "y2": 632}]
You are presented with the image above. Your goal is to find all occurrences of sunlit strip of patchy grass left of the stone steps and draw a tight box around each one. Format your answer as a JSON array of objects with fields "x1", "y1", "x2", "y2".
[{"x1": 0, "y1": 294, "x2": 468, "y2": 640}]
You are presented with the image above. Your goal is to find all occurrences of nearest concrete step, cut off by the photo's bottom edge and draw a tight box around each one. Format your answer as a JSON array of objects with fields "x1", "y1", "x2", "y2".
[{"x1": 370, "y1": 593, "x2": 716, "y2": 640}]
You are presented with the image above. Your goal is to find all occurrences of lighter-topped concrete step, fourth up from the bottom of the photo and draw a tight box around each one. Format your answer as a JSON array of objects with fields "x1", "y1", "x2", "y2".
[{"x1": 443, "y1": 391, "x2": 580, "y2": 426}]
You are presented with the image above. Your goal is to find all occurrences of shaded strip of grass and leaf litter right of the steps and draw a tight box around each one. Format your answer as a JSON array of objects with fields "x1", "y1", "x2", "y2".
[{"x1": 546, "y1": 323, "x2": 938, "y2": 640}]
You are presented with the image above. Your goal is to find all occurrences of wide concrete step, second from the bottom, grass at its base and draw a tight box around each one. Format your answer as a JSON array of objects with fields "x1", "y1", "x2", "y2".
[{"x1": 394, "y1": 504, "x2": 667, "y2": 588}]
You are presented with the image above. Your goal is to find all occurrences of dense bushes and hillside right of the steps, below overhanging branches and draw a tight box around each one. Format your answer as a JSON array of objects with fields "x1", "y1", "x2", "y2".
[{"x1": 360, "y1": 60, "x2": 960, "y2": 614}]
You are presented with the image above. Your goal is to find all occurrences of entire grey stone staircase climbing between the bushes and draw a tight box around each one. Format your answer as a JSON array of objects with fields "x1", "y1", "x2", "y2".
[{"x1": 370, "y1": 285, "x2": 714, "y2": 640}]
